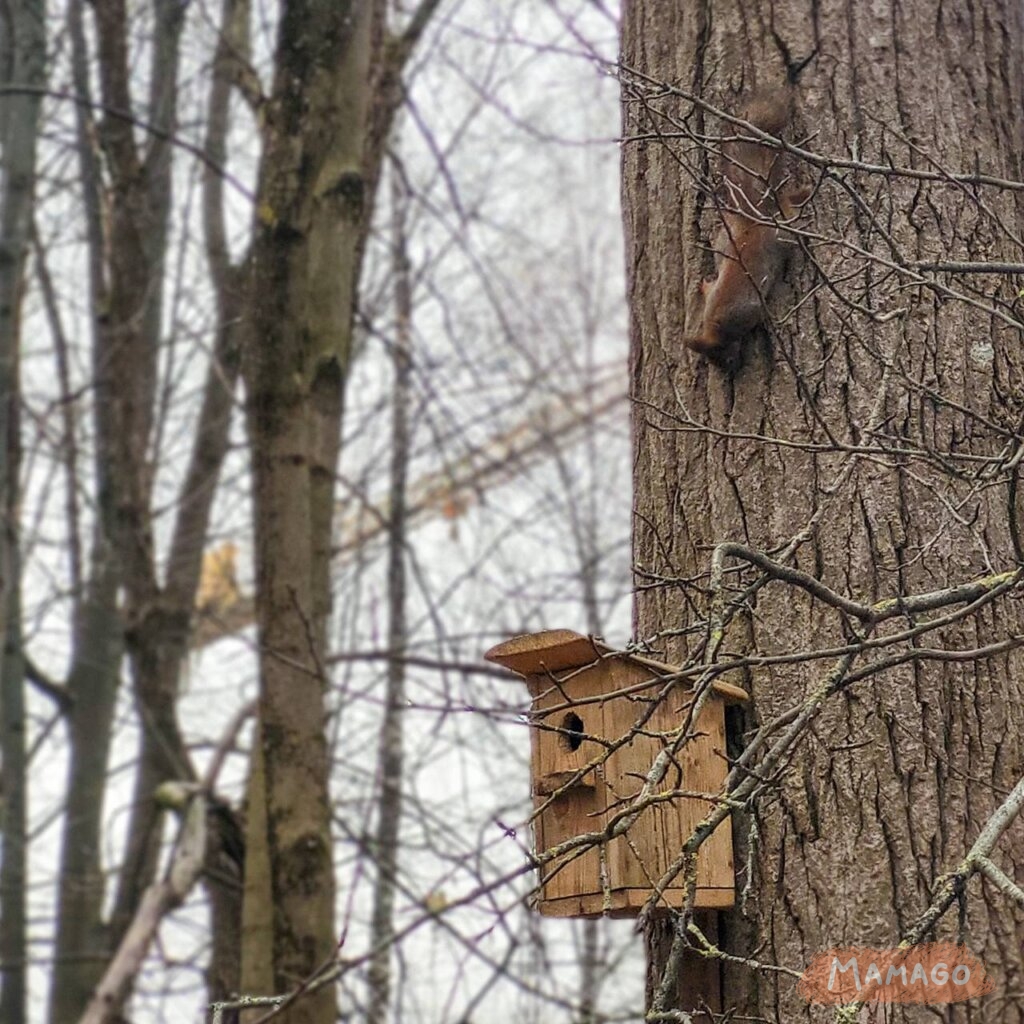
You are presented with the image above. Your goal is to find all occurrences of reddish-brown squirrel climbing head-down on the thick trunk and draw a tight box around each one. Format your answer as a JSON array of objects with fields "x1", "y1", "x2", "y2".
[{"x1": 686, "y1": 86, "x2": 811, "y2": 360}]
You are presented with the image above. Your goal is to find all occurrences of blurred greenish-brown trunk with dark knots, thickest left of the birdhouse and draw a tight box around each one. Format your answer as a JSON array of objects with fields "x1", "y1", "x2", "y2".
[{"x1": 243, "y1": 0, "x2": 439, "y2": 1024}]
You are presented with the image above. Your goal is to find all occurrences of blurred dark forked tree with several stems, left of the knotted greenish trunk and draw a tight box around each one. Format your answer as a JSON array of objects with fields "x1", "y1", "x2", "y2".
[{"x1": 50, "y1": 0, "x2": 251, "y2": 1022}]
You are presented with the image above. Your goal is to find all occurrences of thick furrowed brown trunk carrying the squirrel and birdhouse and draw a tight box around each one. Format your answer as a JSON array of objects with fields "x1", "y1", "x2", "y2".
[{"x1": 623, "y1": 0, "x2": 1024, "y2": 1022}]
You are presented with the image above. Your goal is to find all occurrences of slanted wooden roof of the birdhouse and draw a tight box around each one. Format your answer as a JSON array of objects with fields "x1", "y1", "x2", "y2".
[{"x1": 483, "y1": 630, "x2": 750, "y2": 702}]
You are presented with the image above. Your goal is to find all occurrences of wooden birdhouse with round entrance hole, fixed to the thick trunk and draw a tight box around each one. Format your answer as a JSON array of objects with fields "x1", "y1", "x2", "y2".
[{"x1": 484, "y1": 630, "x2": 746, "y2": 918}]
